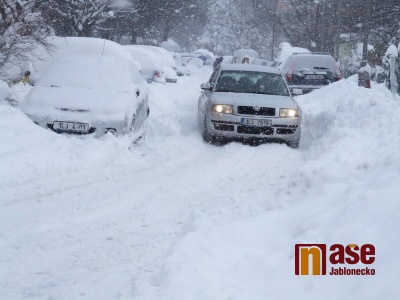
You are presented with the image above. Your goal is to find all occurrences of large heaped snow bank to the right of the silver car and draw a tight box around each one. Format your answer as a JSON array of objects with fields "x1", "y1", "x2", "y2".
[{"x1": 156, "y1": 80, "x2": 400, "y2": 300}]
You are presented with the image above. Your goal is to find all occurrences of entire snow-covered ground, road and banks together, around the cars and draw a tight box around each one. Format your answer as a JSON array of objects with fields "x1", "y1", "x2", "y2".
[{"x1": 0, "y1": 68, "x2": 400, "y2": 300}]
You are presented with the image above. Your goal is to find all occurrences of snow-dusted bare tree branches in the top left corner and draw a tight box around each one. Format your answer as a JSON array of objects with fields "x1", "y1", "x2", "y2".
[{"x1": 0, "y1": 0, "x2": 52, "y2": 80}]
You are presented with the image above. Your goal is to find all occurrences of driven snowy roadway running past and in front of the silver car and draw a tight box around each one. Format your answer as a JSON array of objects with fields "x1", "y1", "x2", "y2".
[{"x1": 0, "y1": 68, "x2": 302, "y2": 299}]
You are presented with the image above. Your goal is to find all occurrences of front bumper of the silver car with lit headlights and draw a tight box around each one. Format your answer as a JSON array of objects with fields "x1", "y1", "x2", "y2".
[{"x1": 207, "y1": 113, "x2": 301, "y2": 142}]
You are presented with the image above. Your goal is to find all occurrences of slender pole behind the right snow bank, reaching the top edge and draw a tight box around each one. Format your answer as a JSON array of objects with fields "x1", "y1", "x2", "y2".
[{"x1": 358, "y1": 0, "x2": 371, "y2": 88}]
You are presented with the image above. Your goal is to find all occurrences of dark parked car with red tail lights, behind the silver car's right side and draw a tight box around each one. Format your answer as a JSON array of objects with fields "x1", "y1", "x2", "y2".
[{"x1": 282, "y1": 53, "x2": 342, "y2": 94}]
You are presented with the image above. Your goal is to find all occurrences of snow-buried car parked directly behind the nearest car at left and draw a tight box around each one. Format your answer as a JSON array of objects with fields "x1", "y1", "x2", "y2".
[{"x1": 125, "y1": 45, "x2": 177, "y2": 83}]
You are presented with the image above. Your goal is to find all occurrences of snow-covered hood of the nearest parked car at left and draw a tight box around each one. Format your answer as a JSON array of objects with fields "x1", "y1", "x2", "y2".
[{"x1": 20, "y1": 86, "x2": 137, "y2": 122}]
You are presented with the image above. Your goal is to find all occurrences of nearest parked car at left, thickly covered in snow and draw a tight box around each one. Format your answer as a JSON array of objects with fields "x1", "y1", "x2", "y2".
[{"x1": 20, "y1": 54, "x2": 149, "y2": 140}]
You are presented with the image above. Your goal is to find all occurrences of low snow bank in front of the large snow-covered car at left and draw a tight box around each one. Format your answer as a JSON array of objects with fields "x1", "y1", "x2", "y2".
[{"x1": 0, "y1": 105, "x2": 130, "y2": 189}]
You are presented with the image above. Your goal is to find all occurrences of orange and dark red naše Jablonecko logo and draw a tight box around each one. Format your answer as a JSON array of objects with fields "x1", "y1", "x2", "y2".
[{"x1": 295, "y1": 244, "x2": 375, "y2": 275}]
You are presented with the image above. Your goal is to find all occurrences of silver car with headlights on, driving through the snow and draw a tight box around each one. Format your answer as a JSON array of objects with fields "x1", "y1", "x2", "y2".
[{"x1": 197, "y1": 64, "x2": 301, "y2": 148}]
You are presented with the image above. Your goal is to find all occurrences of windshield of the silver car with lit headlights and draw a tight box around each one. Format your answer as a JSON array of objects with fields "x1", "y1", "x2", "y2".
[{"x1": 214, "y1": 70, "x2": 289, "y2": 96}]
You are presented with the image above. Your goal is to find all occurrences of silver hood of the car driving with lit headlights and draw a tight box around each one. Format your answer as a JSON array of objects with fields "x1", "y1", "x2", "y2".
[{"x1": 213, "y1": 93, "x2": 298, "y2": 108}]
